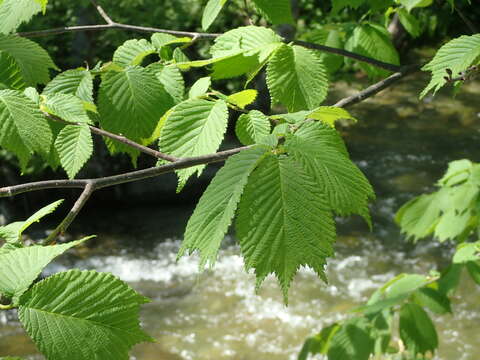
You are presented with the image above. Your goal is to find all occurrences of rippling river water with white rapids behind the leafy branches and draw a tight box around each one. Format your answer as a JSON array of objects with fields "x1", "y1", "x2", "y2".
[{"x1": 0, "y1": 79, "x2": 480, "y2": 360}]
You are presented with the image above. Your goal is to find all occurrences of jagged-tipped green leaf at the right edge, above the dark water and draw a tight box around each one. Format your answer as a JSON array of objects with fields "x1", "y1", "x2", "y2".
[{"x1": 420, "y1": 34, "x2": 480, "y2": 98}]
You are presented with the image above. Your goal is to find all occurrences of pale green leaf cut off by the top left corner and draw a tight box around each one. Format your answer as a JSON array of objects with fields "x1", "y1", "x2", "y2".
[{"x1": 0, "y1": 0, "x2": 42, "y2": 34}]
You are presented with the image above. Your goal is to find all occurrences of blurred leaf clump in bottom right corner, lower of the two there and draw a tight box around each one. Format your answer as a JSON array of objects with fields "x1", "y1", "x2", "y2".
[{"x1": 298, "y1": 242, "x2": 480, "y2": 360}]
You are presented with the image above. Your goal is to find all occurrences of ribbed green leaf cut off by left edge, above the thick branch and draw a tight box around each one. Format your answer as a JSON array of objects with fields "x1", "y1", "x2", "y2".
[{"x1": 0, "y1": 90, "x2": 52, "y2": 170}]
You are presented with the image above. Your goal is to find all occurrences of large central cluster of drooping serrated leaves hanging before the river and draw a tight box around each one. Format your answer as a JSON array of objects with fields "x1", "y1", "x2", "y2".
[{"x1": 179, "y1": 116, "x2": 373, "y2": 300}]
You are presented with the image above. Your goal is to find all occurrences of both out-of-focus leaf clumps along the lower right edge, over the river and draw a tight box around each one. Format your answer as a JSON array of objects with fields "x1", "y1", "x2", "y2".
[{"x1": 298, "y1": 160, "x2": 480, "y2": 360}]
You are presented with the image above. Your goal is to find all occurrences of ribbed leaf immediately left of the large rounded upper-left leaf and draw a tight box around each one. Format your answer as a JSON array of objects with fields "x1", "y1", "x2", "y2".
[{"x1": 43, "y1": 69, "x2": 93, "y2": 104}]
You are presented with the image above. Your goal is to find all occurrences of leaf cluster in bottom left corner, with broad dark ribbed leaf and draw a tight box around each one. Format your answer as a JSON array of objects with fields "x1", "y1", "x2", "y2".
[{"x1": 0, "y1": 200, "x2": 152, "y2": 360}]
